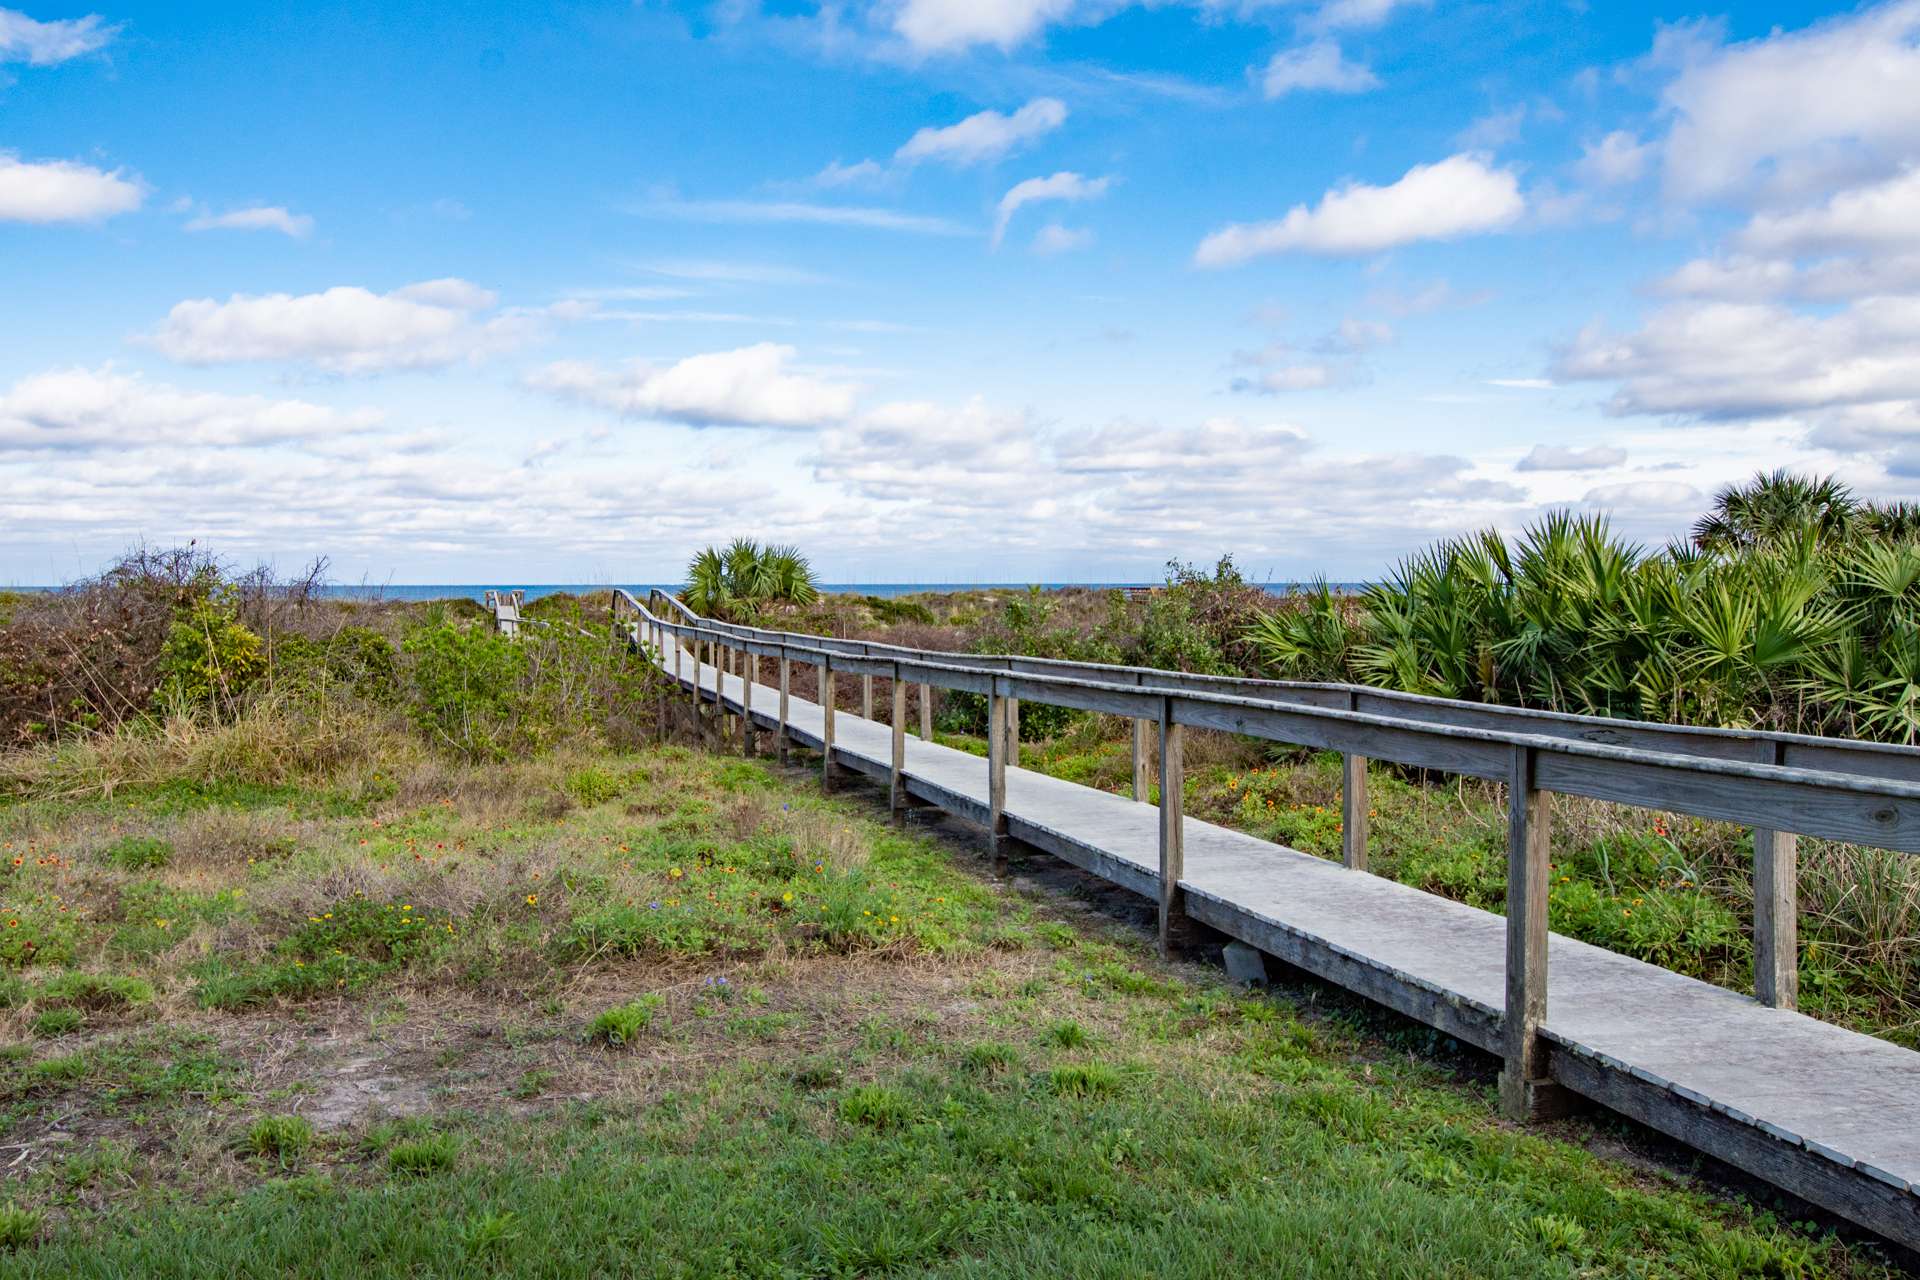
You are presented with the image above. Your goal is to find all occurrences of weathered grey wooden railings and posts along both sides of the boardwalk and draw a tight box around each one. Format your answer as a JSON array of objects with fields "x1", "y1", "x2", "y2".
[{"x1": 614, "y1": 591, "x2": 1920, "y2": 1117}]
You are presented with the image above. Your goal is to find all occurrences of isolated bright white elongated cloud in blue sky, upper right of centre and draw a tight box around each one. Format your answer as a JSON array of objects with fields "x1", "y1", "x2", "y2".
[{"x1": 1194, "y1": 154, "x2": 1526, "y2": 267}]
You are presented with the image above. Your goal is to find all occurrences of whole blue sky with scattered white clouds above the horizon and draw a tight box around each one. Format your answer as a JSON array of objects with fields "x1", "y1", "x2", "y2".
[{"x1": 0, "y1": 0, "x2": 1920, "y2": 581}]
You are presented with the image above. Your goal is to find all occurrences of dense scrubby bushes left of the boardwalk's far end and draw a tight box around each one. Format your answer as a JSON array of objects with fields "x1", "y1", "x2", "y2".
[{"x1": 0, "y1": 549, "x2": 655, "y2": 771}]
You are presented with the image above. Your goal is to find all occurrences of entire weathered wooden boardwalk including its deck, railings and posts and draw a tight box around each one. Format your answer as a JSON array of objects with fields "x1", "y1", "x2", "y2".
[{"x1": 614, "y1": 591, "x2": 1920, "y2": 1247}]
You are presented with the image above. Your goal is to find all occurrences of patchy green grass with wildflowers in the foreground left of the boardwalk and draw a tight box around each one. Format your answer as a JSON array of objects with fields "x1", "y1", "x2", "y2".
[{"x1": 0, "y1": 729, "x2": 1882, "y2": 1278}]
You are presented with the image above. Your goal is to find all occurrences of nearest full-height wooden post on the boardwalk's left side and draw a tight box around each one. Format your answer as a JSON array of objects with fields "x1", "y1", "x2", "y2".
[{"x1": 1500, "y1": 745, "x2": 1572, "y2": 1123}]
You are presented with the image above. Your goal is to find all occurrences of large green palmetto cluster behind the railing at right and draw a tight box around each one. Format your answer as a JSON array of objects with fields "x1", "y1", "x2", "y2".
[{"x1": 1248, "y1": 472, "x2": 1920, "y2": 743}]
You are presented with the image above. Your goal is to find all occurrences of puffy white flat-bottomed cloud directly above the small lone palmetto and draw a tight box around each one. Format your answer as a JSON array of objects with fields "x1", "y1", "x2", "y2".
[{"x1": 530, "y1": 342, "x2": 858, "y2": 428}]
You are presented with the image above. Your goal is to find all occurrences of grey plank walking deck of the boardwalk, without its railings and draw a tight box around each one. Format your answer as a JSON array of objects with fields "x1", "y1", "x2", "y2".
[{"x1": 662, "y1": 637, "x2": 1920, "y2": 1247}]
